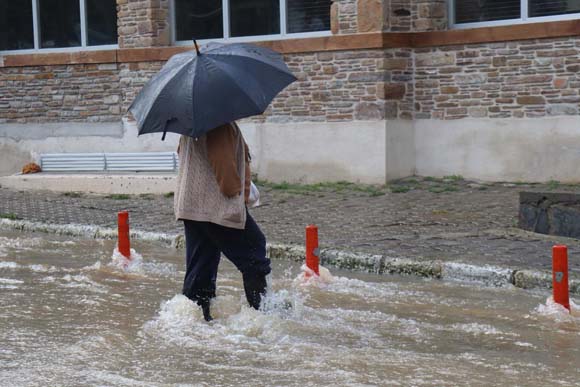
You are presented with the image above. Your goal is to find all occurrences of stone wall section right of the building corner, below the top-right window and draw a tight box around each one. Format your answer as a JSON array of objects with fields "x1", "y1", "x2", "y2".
[{"x1": 415, "y1": 38, "x2": 580, "y2": 119}]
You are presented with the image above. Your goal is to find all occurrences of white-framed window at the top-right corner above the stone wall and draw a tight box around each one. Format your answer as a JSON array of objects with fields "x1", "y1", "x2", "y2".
[{"x1": 450, "y1": 0, "x2": 580, "y2": 27}]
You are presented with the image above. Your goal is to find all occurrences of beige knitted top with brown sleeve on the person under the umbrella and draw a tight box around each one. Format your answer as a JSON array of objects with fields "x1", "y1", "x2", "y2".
[{"x1": 174, "y1": 124, "x2": 250, "y2": 229}]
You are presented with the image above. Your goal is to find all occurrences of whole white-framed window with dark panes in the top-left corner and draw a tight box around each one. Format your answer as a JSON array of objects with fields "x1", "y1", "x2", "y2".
[{"x1": 0, "y1": 0, "x2": 117, "y2": 51}]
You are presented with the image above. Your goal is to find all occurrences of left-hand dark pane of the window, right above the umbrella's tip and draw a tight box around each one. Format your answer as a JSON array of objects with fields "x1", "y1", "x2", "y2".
[{"x1": 175, "y1": 0, "x2": 224, "y2": 40}]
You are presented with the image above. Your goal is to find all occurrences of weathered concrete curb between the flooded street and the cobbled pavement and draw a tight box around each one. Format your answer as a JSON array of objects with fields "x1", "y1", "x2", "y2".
[{"x1": 0, "y1": 219, "x2": 580, "y2": 294}]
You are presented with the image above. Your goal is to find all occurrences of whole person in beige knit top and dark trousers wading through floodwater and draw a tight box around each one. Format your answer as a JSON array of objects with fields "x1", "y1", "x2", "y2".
[{"x1": 174, "y1": 122, "x2": 271, "y2": 321}]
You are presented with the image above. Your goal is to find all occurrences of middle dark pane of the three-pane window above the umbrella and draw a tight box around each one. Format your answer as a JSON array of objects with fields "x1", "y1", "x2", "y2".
[{"x1": 230, "y1": 0, "x2": 280, "y2": 36}]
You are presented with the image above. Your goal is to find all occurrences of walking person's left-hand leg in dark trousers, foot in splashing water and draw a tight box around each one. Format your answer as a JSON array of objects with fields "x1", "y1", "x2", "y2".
[{"x1": 183, "y1": 220, "x2": 220, "y2": 321}]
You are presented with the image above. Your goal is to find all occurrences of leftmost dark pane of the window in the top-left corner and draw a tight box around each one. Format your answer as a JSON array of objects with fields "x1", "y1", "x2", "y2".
[{"x1": 0, "y1": 0, "x2": 34, "y2": 50}]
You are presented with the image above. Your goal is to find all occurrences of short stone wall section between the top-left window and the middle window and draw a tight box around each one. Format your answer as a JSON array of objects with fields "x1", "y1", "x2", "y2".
[{"x1": 117, "y1": 0, "x2": 171, "y2": 48}]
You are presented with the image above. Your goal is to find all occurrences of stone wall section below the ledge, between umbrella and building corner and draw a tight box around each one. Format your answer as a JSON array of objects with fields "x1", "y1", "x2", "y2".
[{"x1": 255, "y1": 50, "x2": 387, "y2": 122}]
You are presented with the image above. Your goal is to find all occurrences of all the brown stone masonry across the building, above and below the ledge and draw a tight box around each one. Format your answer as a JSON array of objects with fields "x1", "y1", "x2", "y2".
[{"x1": 0, "y1": 0, "x2": 580, "y2": 123}]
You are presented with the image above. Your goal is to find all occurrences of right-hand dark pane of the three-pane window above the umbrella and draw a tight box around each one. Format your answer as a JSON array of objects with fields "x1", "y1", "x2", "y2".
[{"x1": 287, "y1": 0, "x2": 332, "y2": 33}]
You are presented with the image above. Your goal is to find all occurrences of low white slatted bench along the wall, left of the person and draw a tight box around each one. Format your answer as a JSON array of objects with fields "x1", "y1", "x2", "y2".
[{"x1": 40, "y1": 152, "x2": 178, "y2": 172}]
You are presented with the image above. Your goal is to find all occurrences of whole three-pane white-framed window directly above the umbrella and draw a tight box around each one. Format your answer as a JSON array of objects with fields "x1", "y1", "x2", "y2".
[{"x1": 173, "y1": 0, "x2": 332, "y2": 42}]
